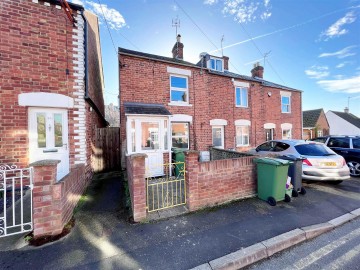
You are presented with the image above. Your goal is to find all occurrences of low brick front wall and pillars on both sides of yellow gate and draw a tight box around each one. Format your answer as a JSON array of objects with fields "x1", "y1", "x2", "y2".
[{"x1": 126, "y1": 151, "x2": 256, "y2": 222}]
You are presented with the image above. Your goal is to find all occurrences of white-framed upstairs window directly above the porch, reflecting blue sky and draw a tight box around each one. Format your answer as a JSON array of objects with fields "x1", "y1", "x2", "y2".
[{"x1": 170, "y1": 75, "x2": 189, "y2": 103}]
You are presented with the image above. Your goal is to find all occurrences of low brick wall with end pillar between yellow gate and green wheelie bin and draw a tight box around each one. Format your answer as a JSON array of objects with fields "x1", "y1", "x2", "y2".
[{"x1": 185, "y1": 151, "x2": 256, "y2": 211}]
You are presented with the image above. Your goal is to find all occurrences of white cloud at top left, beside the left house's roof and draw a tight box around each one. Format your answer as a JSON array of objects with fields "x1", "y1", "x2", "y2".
[{"x1": 86, "y1": 1, "x2": 126, "y2": 30}]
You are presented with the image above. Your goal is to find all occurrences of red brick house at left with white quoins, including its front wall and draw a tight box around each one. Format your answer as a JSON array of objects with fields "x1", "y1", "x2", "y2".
[{"x1": 0, "y1": 0, "x2": 106, "y2": 234}]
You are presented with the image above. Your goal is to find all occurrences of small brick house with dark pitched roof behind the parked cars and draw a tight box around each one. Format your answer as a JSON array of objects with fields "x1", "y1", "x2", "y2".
[{"x1": 303, "y1": 109, "x2": 330, "y2": 140}]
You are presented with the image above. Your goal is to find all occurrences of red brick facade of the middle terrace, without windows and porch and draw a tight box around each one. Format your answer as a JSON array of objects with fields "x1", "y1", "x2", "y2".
[{"x1": 119, "y1": 53, "x2": 302, "y2": 154}]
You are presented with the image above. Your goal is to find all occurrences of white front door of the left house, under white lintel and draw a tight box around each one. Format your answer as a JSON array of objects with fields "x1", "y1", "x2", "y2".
[{"x1": 29, "y1": 108, "x2": 70, "y2": 180}]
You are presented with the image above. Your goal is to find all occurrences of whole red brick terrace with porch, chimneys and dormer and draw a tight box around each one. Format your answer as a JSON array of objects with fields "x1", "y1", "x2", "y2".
[{"x1": 119, "y1": 36, "x2": 302, "y2": 175}]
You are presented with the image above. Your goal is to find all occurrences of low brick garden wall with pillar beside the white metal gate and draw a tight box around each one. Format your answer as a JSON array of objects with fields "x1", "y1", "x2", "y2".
[{"x1": 30, "y1": 160, "x2": 89, "y2": 238}]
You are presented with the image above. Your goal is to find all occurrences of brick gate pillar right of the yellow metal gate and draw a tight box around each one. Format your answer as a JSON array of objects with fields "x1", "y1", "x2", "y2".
[{"x1": 185, "y1": 151, "x2": 199, "y2": 211}]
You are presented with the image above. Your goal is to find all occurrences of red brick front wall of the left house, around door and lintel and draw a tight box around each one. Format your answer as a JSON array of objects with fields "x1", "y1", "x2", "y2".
[{"x1": 0, "y1": 0, "x2": 76, "y2": 168}]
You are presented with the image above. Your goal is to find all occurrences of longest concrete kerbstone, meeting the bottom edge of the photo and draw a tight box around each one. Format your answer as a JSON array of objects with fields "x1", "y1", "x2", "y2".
[{"x1": 209, "y1": 243, "x2": 267, "y2": 270}]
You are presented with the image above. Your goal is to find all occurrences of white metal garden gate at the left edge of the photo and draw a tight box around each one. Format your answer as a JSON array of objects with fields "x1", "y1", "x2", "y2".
[{"x1": 0, "y1": 165, "x2": 33, "y2": 237}]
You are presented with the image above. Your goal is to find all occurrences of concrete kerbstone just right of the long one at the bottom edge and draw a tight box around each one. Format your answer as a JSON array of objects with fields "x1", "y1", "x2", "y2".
[{"x1": 261, "y1": 229, "x2": 306, "y2": 257}]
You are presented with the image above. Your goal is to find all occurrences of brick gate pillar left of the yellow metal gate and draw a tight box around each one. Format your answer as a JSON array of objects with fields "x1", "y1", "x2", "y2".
[{"x1": 127, "y1": 154, "x2": 146, "y2": 222}]
